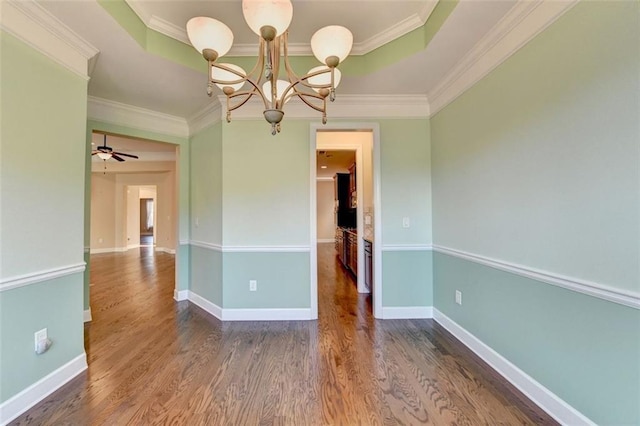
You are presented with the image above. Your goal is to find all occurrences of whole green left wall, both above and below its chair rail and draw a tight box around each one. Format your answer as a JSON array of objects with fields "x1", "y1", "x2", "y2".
[{"x1": 0, "y1": 32, "x2": 87, "y2": 402}]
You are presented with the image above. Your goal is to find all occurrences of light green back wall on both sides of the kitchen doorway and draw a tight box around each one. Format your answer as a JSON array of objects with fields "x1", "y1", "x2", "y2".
[{"x1": 191, "y1": 119, "x2": 432, "y2": 309}]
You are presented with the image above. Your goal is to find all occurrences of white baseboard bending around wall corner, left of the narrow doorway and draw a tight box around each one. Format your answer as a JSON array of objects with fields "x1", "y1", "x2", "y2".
[{"x1": 187, "y1": 290, "x2": 312, "y2": 321}]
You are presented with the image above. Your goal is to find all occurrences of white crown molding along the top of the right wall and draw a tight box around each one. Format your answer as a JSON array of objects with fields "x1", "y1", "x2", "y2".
[{"x1": 428, "y1": 0, "x2": 579, "y2": 115}]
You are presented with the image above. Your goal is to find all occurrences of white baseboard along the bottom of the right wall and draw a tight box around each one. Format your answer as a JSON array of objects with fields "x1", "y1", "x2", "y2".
[{"x1": 433, "y1": 308, "x2": 595, "y2": 425}]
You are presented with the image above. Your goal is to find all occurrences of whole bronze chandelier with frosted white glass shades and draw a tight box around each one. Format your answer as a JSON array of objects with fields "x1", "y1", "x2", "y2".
[{"x1": 187, "y1": 0, "x2": 353, "y2": 135}]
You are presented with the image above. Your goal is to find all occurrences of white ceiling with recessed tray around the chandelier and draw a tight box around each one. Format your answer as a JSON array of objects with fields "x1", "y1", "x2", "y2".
[{"x1": 40, "y1": 0, "x2": 516, "y2": 118}]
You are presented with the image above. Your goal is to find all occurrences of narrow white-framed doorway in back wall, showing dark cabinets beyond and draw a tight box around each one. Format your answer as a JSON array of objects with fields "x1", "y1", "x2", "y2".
[{"x1": 311, "y1": 125, "x2": 381, "y2": 317}]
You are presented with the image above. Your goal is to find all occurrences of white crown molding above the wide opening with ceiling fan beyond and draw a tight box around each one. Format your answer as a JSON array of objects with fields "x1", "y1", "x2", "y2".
[{"x1": 87, "y1": 96, "x2": 189, "y2": 138}]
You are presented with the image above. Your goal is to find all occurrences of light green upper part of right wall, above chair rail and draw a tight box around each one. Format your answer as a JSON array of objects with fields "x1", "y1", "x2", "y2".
[{"x1": 432, "y1": 2, "x2": 640, "y2": 292}]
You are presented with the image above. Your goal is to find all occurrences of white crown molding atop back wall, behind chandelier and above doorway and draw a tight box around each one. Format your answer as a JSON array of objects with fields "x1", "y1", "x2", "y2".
[{"x1": 218, "y1": 95, "x2": 430, "y2": 121}]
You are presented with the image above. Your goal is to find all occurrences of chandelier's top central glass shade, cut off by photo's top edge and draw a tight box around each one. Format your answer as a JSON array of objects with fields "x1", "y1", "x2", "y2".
[{"x1": 242, "y1": 0, "x2": 293, "y2": 37}]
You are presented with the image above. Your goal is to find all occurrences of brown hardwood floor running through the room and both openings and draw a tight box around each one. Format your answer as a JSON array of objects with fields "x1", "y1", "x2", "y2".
[{"x1": 12, "y1": 244, "x2": 555, "y2": 425}]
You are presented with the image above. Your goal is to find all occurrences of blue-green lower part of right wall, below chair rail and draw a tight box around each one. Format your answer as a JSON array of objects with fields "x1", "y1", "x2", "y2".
[{"x1": 434, "y1": 253, "x2": 640, "y2": 425}]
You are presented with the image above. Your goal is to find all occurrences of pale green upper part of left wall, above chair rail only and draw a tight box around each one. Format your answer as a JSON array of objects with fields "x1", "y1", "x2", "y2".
[{"x1": 0, "y1": 32, "x2": 87, "y2": 278}]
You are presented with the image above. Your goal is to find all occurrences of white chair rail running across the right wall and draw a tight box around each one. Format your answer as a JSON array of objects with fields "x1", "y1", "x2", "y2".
[{"x1": 433, "y1": 245, "x2": 640, "y2": 309}]
